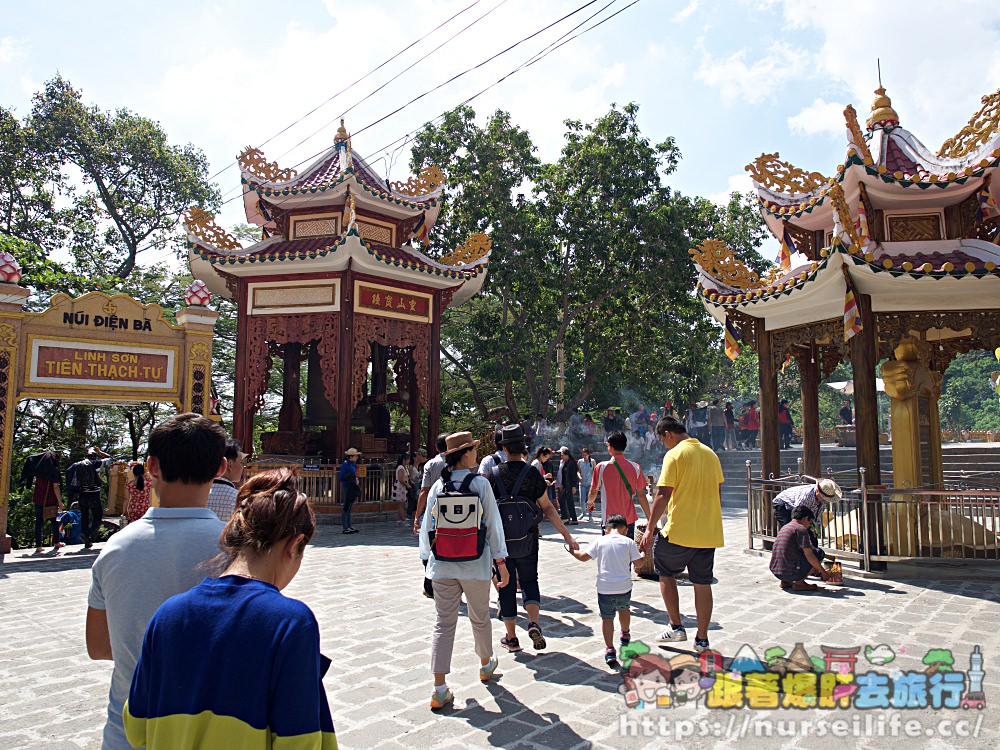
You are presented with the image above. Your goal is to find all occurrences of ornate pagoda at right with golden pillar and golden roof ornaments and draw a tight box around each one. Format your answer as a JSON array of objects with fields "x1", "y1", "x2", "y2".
[{"x1": 692, "y1": 87, "x2": 1000, "y2": 560}]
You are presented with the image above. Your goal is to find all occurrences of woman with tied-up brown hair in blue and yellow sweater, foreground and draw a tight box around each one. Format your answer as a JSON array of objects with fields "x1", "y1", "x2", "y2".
[{"x1": 124, "y1": 469, "x2": 337, "y2": 750}]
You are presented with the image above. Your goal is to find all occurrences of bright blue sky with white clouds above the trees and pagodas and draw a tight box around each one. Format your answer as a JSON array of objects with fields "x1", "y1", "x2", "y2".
[{"x1": 0, "y1": 0, "x2": 1000, "y2": 262}]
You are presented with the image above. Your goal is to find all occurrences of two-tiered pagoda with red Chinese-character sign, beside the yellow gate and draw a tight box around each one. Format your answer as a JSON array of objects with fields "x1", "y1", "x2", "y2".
[{"x1": 185, "y1": 121, "x2": 490, "y2": 459}]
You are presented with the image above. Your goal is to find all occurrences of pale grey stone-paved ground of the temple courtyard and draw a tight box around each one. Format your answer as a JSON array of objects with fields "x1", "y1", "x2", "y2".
[{"x1": 0, "y1": 511, "x2": 1000, "y2": 750}]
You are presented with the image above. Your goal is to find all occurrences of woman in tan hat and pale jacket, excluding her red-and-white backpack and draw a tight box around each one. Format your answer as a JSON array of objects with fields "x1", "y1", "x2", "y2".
[{"x1": 420, "y1": 432, "x2": 510, "y2": 709}]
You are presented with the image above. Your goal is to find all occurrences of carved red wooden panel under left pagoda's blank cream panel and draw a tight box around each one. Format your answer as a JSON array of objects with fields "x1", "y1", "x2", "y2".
[{"x1": 244, "y1": 313, "x2": 340, "y2": 414}]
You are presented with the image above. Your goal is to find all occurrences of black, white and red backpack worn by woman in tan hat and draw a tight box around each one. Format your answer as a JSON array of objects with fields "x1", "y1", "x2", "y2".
[{"x1": 429, "y1": 474, "x2": 486, "y2": 562}]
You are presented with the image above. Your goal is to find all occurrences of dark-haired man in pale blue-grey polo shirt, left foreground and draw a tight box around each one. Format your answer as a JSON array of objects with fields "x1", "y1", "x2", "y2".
[{"x1": 87, "y1": 414, "x2": 226, "y2": 750}]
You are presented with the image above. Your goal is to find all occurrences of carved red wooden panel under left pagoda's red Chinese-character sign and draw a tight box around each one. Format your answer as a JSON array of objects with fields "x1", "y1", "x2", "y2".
[{"x1": 351, "y1": 313, "x2": 431, "y2": 409}]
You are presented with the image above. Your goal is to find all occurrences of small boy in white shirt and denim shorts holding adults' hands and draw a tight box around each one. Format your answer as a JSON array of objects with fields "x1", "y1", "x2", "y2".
[{"x1": 567, "y1": 513, "x2": 642, "y2": 667}]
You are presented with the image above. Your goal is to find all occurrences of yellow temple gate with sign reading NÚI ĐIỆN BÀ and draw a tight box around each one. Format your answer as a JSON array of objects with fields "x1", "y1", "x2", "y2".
[{"x1": 0, "y1": 282, "x2": 218, "y2": 555}]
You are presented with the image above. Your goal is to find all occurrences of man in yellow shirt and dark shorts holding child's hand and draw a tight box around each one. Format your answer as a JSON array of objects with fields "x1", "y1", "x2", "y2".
[{"x1": 639, "y1": 417, "x2": 724, "y2": 653}]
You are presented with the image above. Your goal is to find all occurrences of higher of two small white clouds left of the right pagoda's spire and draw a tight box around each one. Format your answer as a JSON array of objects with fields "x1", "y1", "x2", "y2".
[{"x1": 695, "y1": 42, "x2": 810, "y2": 104}]
